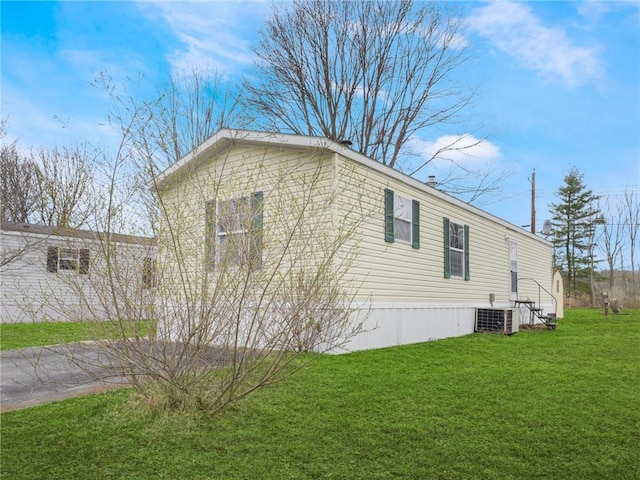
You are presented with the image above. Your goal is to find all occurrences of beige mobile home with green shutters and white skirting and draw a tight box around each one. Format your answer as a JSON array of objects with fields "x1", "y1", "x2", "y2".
[{"x1": 152, "y1": 130, "x2": 561, "y2": 350}]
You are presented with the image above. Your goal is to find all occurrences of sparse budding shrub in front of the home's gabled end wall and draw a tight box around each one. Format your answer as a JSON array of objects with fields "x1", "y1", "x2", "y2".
[{"x1": 45, "y1": 75, "x2": 374, "y2": 413}]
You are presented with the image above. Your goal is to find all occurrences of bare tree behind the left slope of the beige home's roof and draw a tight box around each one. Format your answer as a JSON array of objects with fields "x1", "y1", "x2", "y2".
[{"x1": 93, "y1": 71, "x2": 245, "y2": 235}]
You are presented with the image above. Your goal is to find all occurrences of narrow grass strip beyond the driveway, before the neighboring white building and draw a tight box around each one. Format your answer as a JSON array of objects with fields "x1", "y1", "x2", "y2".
[{"x1": 0, "y1": 322, "x2": 152, "y2": 350}]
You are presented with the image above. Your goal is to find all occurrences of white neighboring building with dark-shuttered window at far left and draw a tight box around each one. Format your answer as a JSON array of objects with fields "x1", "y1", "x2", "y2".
[{"x1": 0, "y1": 222, "x2": 157, "y2": 323}]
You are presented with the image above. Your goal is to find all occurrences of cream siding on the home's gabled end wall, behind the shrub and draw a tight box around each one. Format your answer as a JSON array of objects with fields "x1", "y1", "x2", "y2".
[{"x1": 160, "y1": 146, "x2": 336, "y2": 285}]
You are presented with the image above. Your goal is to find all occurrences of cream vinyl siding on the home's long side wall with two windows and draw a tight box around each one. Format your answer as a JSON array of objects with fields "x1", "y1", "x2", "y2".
[{"x1": 338, "y1": 158, "x2": 551, "y2": 307}]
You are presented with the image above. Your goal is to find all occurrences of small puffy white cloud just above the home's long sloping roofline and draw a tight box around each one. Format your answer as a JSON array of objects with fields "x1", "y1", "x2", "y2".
[{"x1": 409, "y1": 133, "x2": 501, "y2": 166}]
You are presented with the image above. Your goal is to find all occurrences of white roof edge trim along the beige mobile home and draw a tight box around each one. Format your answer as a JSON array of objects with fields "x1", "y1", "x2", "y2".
[{"x1": 156, "y1": 128, "x2": 552, "y2": 246}]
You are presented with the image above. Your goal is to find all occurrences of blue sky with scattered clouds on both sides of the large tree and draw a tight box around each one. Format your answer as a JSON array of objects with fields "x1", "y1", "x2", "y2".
[{"x1": 0, "y1": 1, "x2": 640, "y2": 231}]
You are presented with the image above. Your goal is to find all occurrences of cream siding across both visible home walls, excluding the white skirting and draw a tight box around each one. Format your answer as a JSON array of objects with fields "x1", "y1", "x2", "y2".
[{"x1": 158, "y1": 137, "x2": 551, "y2": 312}]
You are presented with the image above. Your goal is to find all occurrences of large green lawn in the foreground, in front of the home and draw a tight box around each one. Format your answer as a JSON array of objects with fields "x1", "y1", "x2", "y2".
[{"x1": 1, "y1": 310, "x2": 640, "y2": 480}]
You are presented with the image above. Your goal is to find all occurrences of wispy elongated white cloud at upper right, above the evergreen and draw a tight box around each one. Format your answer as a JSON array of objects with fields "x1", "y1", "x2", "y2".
[{"x1": 468, "y1": 2, "x2": 601, "y2": 87}]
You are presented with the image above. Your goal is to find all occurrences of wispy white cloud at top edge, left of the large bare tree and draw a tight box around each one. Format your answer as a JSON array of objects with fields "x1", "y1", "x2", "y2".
[{"x1": 143, "y1": 1, "x2": 269, "y2": 75}]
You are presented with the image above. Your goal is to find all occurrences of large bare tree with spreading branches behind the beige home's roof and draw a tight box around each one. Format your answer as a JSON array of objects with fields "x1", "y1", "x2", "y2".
[{"x1": 245, "y1": 0, "x2": 500, "y2": 198}]
